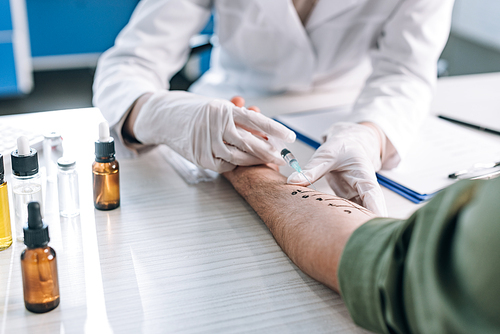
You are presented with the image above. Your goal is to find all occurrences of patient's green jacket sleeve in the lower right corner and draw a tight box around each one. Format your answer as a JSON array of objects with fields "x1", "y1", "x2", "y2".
[{"x1": 338, "y1": 178, "x2": 500, "y2": 333}]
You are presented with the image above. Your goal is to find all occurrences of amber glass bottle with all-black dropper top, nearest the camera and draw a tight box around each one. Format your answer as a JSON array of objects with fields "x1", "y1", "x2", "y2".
[{"x1": 21, "y1": 202, "x2": 59, "y2": 313}]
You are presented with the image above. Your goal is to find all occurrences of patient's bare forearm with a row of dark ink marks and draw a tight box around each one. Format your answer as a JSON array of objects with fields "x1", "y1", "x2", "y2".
[{"x1": 224, "y1": 166, "x2": 375, "y2": 291}]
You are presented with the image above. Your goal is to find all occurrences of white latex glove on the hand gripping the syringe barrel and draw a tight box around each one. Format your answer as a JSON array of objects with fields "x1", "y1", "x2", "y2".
[{"x1": 134, "y1": 91, "x2": 295, "y2": 173}]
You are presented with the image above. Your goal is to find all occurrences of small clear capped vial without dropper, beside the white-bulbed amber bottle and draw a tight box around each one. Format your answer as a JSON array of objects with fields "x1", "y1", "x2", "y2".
[{"x1": 57, "y1": 158, "x2": 80, "y2": 217}]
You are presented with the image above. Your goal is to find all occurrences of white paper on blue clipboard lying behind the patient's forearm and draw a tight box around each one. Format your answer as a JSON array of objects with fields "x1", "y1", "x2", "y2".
[{"x1": 276, "y1": 107, "x2": 500, "y2": 202}]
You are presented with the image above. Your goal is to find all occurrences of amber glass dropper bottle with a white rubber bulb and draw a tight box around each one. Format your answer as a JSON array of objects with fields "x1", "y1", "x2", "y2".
[{"x1": 92, "y1": 122, "x2": 120, "y2": 210}]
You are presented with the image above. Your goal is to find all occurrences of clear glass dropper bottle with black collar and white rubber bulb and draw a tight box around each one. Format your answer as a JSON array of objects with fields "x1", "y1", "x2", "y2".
[{"x1": 11, "y1": 136, "x2": 43, "y2": 241}]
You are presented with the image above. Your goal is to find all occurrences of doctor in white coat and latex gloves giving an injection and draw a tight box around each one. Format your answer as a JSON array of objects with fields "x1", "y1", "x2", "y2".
[{"x1": 94, "y1": 0, "x2": 453, "y2": 215}]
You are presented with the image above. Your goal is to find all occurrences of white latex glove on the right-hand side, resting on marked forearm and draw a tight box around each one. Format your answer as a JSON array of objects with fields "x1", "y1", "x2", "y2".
[{"x1": 288, "y1": 123, "x2": 387, "y2": 216}]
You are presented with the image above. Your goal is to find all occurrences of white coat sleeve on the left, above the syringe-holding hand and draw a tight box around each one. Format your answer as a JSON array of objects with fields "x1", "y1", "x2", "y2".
[{"x1": 93, "y1": 0, "x2": 212, "y2": 127}]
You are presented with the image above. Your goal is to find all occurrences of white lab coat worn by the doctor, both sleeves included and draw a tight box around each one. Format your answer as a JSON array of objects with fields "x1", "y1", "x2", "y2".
[{"x1": 94, "y1": 0, "x2": 453, "y2": 160}]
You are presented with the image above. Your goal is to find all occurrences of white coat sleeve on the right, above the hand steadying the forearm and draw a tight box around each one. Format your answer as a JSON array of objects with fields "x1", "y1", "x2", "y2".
[{"x1": 350, "y1": 0, "x2": 454, "y2": 167}]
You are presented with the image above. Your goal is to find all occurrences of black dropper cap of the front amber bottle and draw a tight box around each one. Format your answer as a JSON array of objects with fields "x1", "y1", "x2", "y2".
[{"x1": 23, "y1": 202, "x2": 50, "y2": 248}]
